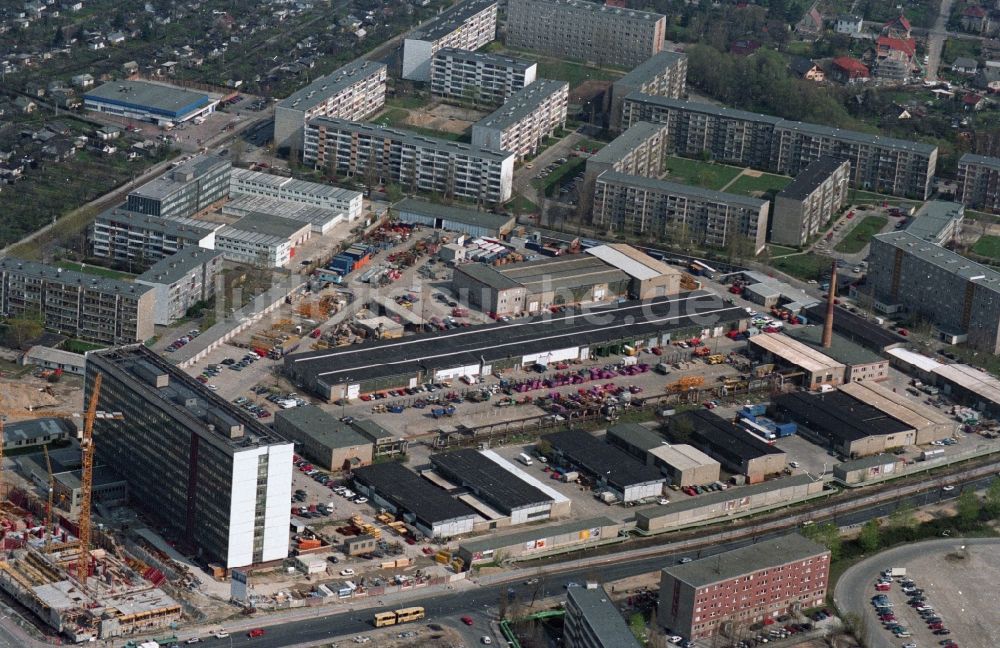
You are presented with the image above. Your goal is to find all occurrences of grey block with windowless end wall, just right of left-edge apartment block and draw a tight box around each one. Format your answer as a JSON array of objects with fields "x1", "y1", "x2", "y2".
[{"x1": 135, "y1": 247, "x2": 222, "y2": 326}]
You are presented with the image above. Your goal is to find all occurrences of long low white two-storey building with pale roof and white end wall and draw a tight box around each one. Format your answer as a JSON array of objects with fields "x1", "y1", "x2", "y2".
[{"x1": 229, "y1": 169, "x2": 363, "y2": 222}]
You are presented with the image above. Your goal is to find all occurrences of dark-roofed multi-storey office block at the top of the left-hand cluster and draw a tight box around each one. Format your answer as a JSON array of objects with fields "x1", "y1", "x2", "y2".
[{"x1": 125, "y1": 154, "x2": 233, "y2": 218}]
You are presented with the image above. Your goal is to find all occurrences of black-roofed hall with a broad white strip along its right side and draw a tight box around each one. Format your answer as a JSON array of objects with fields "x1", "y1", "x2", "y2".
[{"x1": 424, "y1": 449, "x2": 570, "y2": 530}]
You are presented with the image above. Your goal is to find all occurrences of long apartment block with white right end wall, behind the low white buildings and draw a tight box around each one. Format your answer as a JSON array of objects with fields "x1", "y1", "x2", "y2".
[{"x1": 305, "y1": 117, "x2": 514, "y2": 204}]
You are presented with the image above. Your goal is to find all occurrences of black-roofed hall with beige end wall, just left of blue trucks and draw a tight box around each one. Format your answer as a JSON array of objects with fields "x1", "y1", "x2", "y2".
[{"x1": 667, "y1": 409, "x2": 788, "y2": 484}]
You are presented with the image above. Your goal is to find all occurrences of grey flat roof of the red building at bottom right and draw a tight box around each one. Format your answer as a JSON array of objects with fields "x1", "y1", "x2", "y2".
[{"x1": 663, "y1": 533, "x2": 830, "y2": 588}]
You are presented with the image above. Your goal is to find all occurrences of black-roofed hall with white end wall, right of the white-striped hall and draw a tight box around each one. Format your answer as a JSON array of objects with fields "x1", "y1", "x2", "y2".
[{"x1": 542, "y1": 430, "x2": 666, "y2": 503}]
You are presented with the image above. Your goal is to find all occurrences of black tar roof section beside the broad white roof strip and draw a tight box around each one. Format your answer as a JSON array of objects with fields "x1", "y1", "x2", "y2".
[{"x1": 431, "y1": 450, "x2": 552, "y2": 514}]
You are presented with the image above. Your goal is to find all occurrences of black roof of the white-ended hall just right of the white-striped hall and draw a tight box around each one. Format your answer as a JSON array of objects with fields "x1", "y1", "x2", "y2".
[{"x1": 542, "y1": 430, "x2": 665, "y2": 489}]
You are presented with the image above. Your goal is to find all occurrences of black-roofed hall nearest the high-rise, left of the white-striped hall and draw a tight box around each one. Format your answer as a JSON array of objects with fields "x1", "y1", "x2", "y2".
[{"x1": 350, "y1": 461, "x2": 479, "y2": 538}]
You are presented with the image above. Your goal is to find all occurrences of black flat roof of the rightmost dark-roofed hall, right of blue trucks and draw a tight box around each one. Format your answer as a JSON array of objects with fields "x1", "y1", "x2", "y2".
[{"x1": 774, "y1": 391, "x2": 915, "y2": 443}]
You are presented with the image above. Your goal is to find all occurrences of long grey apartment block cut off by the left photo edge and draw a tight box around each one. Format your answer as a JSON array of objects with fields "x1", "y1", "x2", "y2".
[{"x1": 0, "y1": 257, "x2": 155, "y2": 345}]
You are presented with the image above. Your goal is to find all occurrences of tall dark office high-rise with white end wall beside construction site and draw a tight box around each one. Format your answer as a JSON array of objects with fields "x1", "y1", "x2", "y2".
[{"x1": 84, "y1": 344, "x2": 293, "y2": 568}]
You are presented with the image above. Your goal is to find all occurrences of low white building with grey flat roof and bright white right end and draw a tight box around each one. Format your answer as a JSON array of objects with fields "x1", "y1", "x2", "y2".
[{"x1": 215, "y1": 212, "x2": 312, "y2": 268}]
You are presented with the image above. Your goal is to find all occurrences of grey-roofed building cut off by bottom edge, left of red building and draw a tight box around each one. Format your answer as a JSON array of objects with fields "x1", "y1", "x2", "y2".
[{"x1": 563, "y1": 583, "x2": 640, "y2": 648}]
